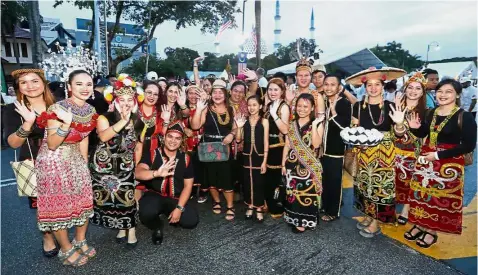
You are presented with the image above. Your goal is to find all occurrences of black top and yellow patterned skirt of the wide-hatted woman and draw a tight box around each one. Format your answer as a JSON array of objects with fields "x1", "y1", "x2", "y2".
[{"x1": 353, "y1": 101, "x2": 396, "y2": 223}]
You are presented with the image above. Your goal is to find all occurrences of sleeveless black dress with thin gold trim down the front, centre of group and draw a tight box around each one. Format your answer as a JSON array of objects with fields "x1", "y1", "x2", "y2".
[{"x1": 242, "y1": 118, "x2": 264, "y2": 208}]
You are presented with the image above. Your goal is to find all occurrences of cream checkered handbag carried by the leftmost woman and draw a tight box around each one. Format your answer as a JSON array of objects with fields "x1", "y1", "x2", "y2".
[{"x1": 10, "y1": 119, "x2": 37, "y2": 197}]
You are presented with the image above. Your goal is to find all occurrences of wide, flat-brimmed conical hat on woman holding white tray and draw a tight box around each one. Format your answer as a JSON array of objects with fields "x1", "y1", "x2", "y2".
[{"x1": 345, "y1": 67, "x2": 407, "y2": 85}]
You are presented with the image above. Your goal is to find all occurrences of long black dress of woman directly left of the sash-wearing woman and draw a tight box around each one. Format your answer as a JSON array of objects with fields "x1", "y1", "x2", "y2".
[{"x1": 264, "y1": 101, "x2": 288, "y2": 215}]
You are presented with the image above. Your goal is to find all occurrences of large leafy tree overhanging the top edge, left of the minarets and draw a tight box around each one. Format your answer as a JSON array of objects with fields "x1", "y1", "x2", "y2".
[{"x1": 55, "y1": 0, "x2": 239, "y2": 72}]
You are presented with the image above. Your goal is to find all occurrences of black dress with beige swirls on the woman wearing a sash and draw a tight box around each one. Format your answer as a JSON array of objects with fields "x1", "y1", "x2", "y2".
[{"x1": 284, "y1": 121, "x2": 322, "y2": 228}]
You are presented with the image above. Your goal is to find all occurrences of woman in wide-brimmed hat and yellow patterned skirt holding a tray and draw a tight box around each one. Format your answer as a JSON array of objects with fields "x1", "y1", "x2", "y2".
[{"x1": 346, "y1": 67, "x2": 406, "y2": 238}]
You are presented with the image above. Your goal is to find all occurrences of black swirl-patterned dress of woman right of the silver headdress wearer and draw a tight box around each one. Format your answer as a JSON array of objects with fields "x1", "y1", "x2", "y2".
[{"x1": 90, "y1": 112, "x2": 138, "y2": 230}]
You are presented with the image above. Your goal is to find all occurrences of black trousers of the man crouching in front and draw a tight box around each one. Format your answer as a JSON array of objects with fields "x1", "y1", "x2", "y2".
[{"x1": 139, "y1": 191, "x2": 199, "y2": 230}]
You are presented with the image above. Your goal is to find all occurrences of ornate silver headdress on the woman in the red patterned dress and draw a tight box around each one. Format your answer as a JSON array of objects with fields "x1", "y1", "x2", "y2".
[{"x1": 39, "y1": 40, "x2": 102, "y2": 98}]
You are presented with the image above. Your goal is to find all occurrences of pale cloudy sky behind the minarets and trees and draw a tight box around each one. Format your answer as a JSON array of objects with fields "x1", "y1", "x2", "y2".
[{"x1": 40, "y1": 0, "x2": 478, "y2": 60}]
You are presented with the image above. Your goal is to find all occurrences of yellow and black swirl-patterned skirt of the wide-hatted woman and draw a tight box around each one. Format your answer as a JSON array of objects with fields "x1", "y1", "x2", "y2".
[{"x1": 354, "y1": 132, "x2": 396, "y2": 223}]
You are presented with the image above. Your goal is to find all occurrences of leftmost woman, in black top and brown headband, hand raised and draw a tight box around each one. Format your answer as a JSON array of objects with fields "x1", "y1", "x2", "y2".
[{"x1": 2, "y1": 69, "x2": 60, "y2": 258}]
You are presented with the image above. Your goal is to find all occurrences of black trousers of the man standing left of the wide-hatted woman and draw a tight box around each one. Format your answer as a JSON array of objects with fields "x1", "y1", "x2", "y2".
[{"x1": 321, "y1": 156, "x2": 344, "y2": 217}]
